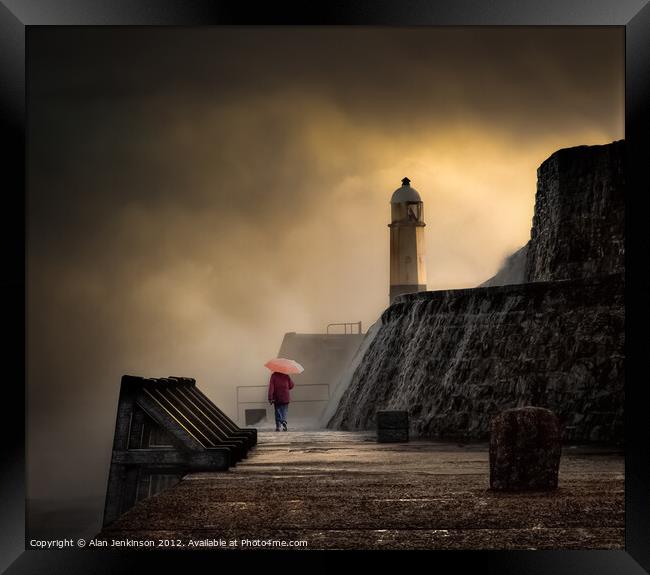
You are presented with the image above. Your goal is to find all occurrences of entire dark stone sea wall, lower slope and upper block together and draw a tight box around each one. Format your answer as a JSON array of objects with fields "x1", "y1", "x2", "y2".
[{"x1": 328, "y1": 142, "x2": 624, "y2": 441}]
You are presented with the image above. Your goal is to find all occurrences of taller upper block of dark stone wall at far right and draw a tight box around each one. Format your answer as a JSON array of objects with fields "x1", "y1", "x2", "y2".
[{"x1": 524, "y1": 140, "x2": 625, "y2": 282}]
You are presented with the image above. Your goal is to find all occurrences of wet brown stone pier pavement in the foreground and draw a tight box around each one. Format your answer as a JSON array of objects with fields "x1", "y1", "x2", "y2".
[{"x1": 98, "y1": 431, "x2": 624, "y2": 549}]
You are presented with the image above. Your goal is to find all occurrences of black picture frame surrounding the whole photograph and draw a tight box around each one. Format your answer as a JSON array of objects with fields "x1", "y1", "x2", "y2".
[{"x1": 0, "y1": 0, "x2": 650, "y2": 575}]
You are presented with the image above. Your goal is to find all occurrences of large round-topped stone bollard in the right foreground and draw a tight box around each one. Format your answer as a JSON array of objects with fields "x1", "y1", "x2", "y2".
[{"x1": 490, "y1": 407, "x2": 562, "y2": 491}]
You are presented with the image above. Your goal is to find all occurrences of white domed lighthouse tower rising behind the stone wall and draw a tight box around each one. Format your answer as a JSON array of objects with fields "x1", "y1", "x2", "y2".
[{"x1": 388, "y1": 178, "x2": 427, "y2": 303}]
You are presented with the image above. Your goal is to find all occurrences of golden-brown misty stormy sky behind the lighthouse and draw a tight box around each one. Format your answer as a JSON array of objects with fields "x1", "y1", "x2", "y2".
[{"x1": 27, "y1": 27, "x2": 624, "y2": 506}]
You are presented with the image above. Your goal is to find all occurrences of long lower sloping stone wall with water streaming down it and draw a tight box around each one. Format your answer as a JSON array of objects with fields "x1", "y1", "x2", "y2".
[{"x1": 329, "y1": 274, "x2": 624, "y2": 441}]
